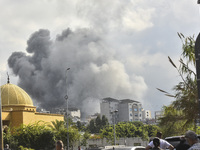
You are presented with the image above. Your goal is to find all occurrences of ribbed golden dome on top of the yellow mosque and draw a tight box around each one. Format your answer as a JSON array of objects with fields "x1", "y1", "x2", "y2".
[{"x1": 1, "y1": 83, "x2": 33, "y2": 106}]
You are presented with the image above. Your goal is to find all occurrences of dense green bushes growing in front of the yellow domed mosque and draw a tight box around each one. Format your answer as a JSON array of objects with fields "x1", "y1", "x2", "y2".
[{"x1": 4, "y1": 121, "x2": 80, "y2": 150}]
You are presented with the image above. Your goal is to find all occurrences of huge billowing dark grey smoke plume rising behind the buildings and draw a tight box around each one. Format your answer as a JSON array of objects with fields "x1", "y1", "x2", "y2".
[{"x1": 8, "y1": 29, "x2": 147, "y2": 117}]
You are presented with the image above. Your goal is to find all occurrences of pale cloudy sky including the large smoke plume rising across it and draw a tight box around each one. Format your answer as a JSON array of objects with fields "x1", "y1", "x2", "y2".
[{"x1": 0, "y1": 0, "x2": 200, "y2": 115}]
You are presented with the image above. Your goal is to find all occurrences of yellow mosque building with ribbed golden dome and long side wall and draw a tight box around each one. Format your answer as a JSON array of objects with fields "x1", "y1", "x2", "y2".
[{"x1": 1, "y1": 78, "x2": 64, "y2": 127}]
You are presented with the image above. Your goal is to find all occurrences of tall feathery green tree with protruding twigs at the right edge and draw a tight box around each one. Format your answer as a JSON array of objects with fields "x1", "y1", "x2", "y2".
[{"x1": 158, "y1": 33, "x2": 199, "y2": 131}]
